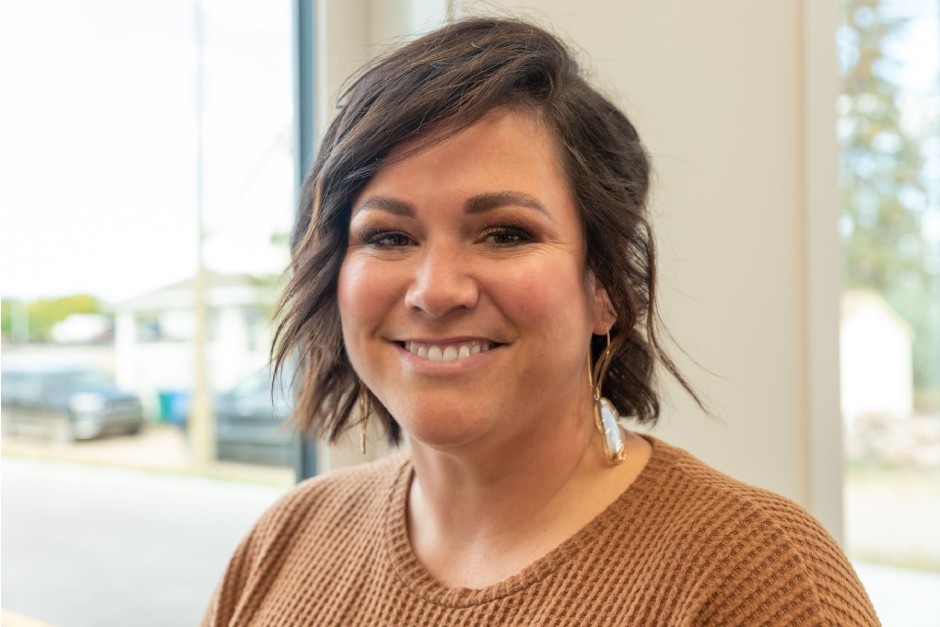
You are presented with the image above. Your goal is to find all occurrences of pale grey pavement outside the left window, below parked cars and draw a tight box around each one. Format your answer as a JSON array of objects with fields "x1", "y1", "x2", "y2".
[{"x1": 0, "y1": 457, "x2": 284, "y2": 627}]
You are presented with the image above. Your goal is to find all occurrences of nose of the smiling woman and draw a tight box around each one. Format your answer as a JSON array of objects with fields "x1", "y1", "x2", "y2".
[{"x1": 405, "y1": 245, "x2": 480, "y2": 318}]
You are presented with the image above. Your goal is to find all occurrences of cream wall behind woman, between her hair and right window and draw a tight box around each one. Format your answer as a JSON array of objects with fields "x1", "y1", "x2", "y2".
[{"x1": 323, "y1": 0, "x2": 841, "y2": 536}]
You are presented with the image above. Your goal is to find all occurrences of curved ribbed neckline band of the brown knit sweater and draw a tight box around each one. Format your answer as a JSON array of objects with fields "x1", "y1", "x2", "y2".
[{"x1": 384, "y1": 435, "x2": 673, "y2": 608}]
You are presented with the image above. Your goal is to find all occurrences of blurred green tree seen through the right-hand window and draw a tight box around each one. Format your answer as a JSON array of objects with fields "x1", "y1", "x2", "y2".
[{"x1": 839, "y1": 0, "x2": 940, "y2": 410}]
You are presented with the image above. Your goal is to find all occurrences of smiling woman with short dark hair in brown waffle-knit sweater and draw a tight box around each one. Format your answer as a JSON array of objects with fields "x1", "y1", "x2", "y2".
[{"x1": 204, "y1": 20, "x2": 877, "y2": 625}]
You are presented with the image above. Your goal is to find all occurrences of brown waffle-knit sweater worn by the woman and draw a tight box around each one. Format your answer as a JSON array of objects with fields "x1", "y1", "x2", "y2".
[{"x1": 203, "y1": 439, "x2": 878, "y2": 626}]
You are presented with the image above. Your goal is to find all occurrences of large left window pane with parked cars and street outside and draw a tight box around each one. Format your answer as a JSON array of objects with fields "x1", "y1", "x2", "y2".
[{"x1": 0, "y1": 0, "x2": 296, "y2": 625}]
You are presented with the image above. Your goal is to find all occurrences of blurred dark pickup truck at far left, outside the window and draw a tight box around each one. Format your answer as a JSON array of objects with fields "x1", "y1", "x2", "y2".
[{"x1": 0, "y1": 366, "x2": 144, "y2": 442}]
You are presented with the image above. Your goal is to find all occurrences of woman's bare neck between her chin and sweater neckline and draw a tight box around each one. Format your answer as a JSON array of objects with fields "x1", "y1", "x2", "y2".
[{"x1": 408, "y1": 392, "x2": 648, "y2": 587}]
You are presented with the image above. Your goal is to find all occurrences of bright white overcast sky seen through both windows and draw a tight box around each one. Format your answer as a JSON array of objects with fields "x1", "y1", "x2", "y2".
[{"x1": 0, "y1": 0, "x2": 940, "y2": 302}]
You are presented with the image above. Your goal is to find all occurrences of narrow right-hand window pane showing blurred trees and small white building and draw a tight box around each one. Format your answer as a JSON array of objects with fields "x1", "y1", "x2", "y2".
[{"x1": 838, "y1": 0, "x2": 940, "y2": 625}]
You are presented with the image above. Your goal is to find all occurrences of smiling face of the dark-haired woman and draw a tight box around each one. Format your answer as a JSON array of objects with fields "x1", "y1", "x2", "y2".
[{"x1": 339, "y1": 110, "x2": 612, "y2": 448}]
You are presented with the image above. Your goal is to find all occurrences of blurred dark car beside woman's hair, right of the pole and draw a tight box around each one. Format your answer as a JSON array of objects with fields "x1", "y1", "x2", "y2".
[{"x1": 214, "y1": 368, "x2": 295, "y2": 466}]
